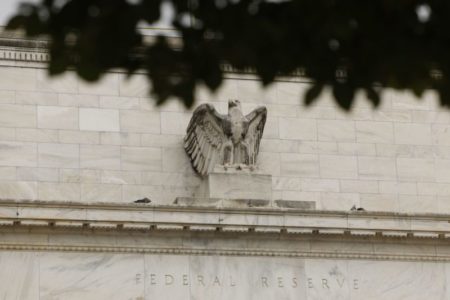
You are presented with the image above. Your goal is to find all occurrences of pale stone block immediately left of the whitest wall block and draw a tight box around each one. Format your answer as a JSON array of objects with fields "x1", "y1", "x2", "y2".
[{"x1": 37, "y1": 106, "x2": 78, "y2": 129}]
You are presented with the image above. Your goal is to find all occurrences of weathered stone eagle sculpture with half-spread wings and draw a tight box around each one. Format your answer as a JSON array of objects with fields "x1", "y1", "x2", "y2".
[{"x1": 184, "y1": 100, "x2": 267, "y2": 176}]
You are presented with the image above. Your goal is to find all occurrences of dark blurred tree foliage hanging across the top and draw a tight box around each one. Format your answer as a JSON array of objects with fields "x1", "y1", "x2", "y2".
[{"x1": 7, "y1": 0, "x2": 450, "y2": 109}]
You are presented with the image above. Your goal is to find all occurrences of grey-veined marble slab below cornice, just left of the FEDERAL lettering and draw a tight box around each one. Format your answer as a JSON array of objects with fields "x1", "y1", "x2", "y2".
[{"x1": 39, "y1": 253, "x2": 144, "y2": 300}]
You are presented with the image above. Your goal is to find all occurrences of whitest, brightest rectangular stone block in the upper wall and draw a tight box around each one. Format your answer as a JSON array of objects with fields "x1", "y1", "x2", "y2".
[{"x1": 80, "y1": 108, "x2": 120, "y2": 131}]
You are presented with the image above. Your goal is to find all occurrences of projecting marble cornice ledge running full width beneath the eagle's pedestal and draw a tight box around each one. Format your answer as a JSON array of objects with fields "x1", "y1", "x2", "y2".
[{"x1": 0, "y1": 200, "x2": 450, "y2": 239}]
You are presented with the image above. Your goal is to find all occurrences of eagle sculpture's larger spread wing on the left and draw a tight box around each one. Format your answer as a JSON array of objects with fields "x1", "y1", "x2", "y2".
[{"x1": 184, "y1": 104, "x2": 226, "y2": 176}]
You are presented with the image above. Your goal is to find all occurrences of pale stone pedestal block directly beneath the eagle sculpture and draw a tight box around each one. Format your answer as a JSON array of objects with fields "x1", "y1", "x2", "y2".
[{"x1": 196, "y1": 166, "x2": 272, "y2": 200}]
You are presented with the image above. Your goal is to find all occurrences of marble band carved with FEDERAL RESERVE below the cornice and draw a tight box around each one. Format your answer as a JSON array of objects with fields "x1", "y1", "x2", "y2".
[{"x1": 0, "y1": 252, "x2": 450, "y2": 300}]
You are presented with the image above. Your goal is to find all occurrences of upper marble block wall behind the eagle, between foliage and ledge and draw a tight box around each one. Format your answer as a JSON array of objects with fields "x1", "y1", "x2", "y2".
[{"x1": 0, "y1": 37, "x2": 450, "y2": 213}]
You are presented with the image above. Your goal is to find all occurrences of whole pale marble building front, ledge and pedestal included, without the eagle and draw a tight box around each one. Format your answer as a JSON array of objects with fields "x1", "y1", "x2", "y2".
[{"x1": 0, "y1": 31, "x2": 450, "y2": 300}]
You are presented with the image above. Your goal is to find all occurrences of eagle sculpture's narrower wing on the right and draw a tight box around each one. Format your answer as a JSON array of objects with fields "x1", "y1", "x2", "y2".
[{"x1": 245, "y1": 106, "x2": 267, "y2": 165}]
